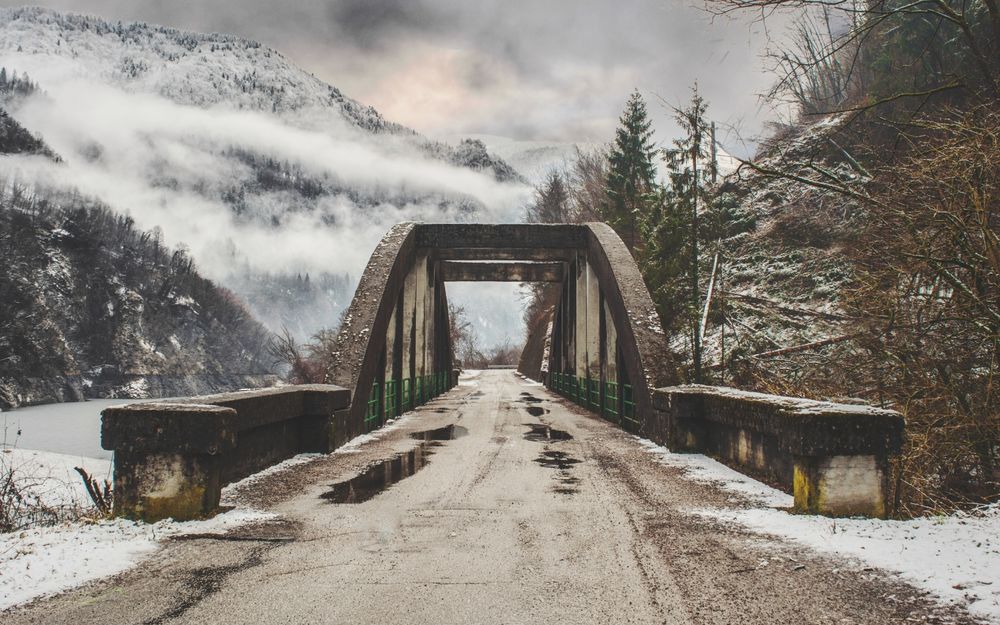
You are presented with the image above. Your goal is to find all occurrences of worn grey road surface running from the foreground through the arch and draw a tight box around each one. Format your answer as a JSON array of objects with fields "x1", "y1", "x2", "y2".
[{"x1": 0, "y1": 371, "x2": 971, "y2": 625}]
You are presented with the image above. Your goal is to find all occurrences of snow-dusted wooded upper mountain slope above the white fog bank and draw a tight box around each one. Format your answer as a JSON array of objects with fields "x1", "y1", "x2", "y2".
[{"x1": 0, "y1": 7, "x2": 413, "y2": 134}]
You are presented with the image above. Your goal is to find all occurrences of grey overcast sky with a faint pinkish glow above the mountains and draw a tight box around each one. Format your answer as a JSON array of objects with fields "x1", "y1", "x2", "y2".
[{"x1": 3, "y1": 0, "x2": 788, "y2": 154}]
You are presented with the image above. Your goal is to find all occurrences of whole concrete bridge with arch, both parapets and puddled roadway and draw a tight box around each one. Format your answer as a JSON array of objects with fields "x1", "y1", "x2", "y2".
[{"x1": 12, "y1": 224, "x2": 935, "y2": 624}]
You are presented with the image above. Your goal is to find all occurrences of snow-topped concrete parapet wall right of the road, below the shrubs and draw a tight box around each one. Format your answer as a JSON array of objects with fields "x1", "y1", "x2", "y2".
[{"x1": 653, "y1": 385, "x2": 904, "y2": 517}]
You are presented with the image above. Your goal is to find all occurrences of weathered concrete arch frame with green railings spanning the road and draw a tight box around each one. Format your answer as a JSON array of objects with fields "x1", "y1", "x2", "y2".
[{"x1": 328, "y1": 223, "x2": 677, "y2": 444}]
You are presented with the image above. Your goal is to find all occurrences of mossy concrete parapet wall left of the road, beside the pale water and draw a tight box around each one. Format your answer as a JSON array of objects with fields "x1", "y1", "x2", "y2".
[{"x1": 101, "y1": 384, "x2": 350, "y2": 522}]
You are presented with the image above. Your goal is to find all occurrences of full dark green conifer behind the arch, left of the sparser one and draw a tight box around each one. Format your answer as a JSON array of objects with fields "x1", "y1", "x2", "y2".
[{"x1": 601, "y1": 91, "x2": 657, "y2": 255}]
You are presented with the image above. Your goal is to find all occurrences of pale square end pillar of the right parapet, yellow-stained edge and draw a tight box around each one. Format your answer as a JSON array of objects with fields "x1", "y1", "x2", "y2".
[{"x1": 793, "y1": 455, "x2": 886, "y2": 518}]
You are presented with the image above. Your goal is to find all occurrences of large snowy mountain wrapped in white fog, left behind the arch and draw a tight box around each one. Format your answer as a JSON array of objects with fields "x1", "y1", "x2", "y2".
[{"x1": 0, "y1": 8, "x2": 530, "y2": 346}]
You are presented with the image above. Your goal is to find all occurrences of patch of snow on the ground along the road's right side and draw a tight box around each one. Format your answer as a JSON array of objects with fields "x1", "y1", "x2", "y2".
[{"x1": 639, "y1": 439, "x2": 1000, "y2": 622}]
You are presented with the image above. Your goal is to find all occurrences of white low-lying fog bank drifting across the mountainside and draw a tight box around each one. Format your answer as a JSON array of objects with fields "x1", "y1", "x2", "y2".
[{"x1": 4, "y1": 77, "x2": 528, "y2": 279}]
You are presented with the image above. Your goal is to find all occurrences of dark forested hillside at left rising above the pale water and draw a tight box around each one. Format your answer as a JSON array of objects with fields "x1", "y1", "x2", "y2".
[{"x1": 0, "y1": 180, "x2": 274, "y2": 408}]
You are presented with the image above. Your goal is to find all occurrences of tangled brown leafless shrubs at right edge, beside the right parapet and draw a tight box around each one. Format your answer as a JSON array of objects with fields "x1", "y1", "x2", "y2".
[{"x1": 849, "y1": 103, "x2": 1000, "y2": 514}]
